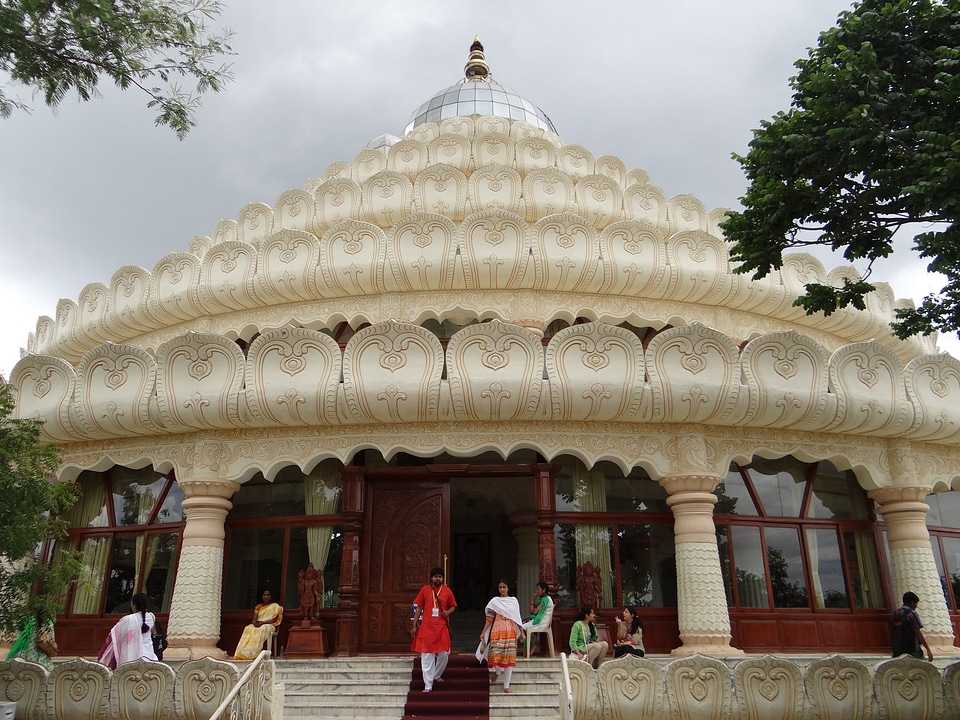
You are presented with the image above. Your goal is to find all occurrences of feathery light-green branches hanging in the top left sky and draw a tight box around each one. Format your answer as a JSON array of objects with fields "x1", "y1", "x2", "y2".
[{"x1": 0, "y1": 0, "x2": 232, "y2": 139}]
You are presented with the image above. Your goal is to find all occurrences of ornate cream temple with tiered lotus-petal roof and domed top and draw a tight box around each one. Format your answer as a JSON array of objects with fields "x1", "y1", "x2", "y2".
[{"x1": 11, "y1": 35, "x2": 960, "y2": 658}]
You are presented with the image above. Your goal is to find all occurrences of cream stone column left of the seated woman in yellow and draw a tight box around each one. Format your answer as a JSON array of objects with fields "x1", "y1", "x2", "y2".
[{"x1": 164, "y1": 479, "x2": 240, "y2": 660}]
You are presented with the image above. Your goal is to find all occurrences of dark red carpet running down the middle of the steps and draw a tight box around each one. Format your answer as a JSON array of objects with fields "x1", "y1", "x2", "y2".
[{"x1": 403, "y1": 653, "x2": 492, "y2": 720}]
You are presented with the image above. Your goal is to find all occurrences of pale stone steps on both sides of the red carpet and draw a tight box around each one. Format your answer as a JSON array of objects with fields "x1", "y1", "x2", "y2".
[{"x1": 275, "y1": 656, "x2": 560, "y2": 720}]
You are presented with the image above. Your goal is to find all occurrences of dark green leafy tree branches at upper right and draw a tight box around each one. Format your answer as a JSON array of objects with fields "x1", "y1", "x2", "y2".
[{"x1": 722, "y1": 0, "x2": 960, "y2": 338}]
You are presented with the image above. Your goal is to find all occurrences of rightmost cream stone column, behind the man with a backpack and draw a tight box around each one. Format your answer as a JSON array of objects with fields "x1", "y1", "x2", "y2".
[{"x1": 868, "y1": 485, "x2": 960, "y2": 656}]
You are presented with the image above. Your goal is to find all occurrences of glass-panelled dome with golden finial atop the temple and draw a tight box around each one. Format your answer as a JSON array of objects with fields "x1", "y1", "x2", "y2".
[{"x1": 403, "y1": 38, "x2": 557, "y2": 135}]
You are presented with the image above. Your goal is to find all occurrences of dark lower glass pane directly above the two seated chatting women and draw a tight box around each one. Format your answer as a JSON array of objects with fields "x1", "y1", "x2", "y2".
[{"x1": 617, "y1": 525, "x2": 677, "y2": 607}]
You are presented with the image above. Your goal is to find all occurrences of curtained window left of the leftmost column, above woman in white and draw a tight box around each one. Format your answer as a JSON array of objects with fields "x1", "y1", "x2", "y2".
[{"x1": 53, "y1": 465, "x2": 184, "y2": 615}]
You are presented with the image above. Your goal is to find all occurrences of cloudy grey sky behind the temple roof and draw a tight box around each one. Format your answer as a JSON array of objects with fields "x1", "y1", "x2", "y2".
[{"x1": 0, "y1": 0, "x2": 960, "y2": 376}]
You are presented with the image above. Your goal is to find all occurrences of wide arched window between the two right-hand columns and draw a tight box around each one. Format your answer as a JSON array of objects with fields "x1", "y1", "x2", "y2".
[{"x1": 714, "y1": 457, "x2": 885, "y2": 610}]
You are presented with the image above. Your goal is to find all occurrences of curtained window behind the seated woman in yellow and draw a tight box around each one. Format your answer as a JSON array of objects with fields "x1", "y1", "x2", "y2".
[{"x1": 223, "y1": 460, "x2": 343, "y2": 610}]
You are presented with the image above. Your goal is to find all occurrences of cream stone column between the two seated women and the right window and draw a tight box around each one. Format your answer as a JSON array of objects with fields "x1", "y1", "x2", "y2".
[{"x1": 660, "y1": 474, "x2": 743, "y2": 657}]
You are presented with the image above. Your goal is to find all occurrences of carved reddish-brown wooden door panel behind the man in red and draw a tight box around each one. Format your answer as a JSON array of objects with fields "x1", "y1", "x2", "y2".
[{"x1": 359, "y1": 478, "x2": 450, "y2": 653}]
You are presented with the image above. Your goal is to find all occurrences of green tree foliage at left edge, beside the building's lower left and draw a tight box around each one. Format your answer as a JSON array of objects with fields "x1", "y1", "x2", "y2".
[{"x1": 0, "y1": 377, "x2": 80, "y2": 635}]
